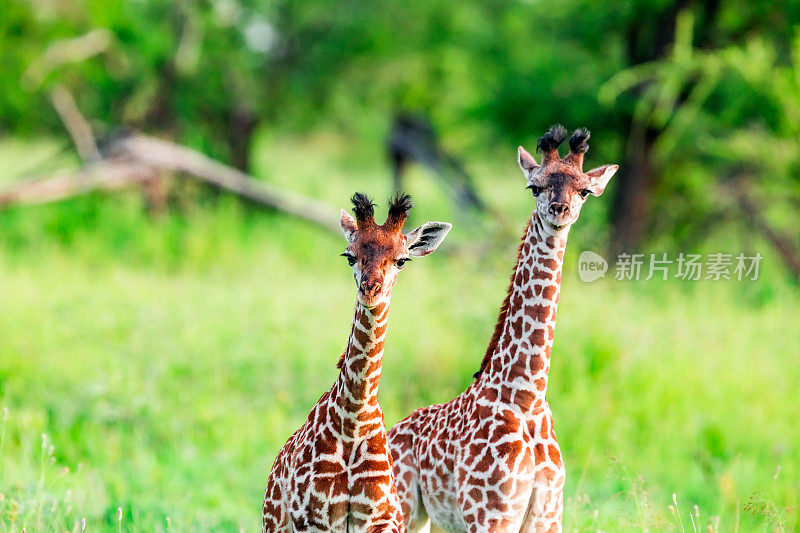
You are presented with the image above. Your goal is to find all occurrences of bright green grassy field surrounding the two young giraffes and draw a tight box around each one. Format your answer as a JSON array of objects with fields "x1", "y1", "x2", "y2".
[{"x1": 0, "y1": 135, "x2": 800, "y2": 531}]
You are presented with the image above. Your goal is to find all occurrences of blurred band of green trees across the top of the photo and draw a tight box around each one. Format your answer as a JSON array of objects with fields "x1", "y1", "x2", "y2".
[{"x1": 0, "y1": 0, "x2": 800, "y2": 264}]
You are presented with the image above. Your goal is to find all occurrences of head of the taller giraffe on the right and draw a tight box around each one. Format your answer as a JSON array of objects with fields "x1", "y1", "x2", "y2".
[{"x1": 519, "y1": 124, "x2": 619, "y2": 231}]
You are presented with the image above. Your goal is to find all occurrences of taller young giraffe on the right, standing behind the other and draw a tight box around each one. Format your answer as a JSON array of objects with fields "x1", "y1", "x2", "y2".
[{"x1": 389, "y1": 126, "x2": 618, "y2": 532}]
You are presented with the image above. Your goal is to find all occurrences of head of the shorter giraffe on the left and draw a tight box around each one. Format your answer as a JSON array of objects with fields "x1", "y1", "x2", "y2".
[{"x1": 341, "y1": 193, "x2": 452, "y2": 307}]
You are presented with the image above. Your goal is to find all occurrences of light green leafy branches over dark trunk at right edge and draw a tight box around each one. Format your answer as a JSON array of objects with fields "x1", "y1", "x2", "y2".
[{"x1": 600, "y1": 11, "x2": 800, "y2": 246}]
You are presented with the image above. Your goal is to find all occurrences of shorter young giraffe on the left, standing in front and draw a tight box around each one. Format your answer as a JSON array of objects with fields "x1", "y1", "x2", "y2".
[{"x1": 262, "y1": 193, "x2": 451, "y2": 533}]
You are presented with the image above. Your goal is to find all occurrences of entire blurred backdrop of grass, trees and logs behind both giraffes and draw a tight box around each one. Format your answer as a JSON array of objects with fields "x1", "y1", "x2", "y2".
[{"x1": 0, "y1": 0, "x2": 800, "y2": 531}]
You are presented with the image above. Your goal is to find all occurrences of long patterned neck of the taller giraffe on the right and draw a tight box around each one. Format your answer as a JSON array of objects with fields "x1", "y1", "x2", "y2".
[{"x1": 483, "y1": 212, "x2": 569, "y2": 414}]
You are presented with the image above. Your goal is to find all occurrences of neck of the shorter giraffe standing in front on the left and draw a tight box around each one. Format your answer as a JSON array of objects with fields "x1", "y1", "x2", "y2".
[{"x1": 331, "y1": 299, "x2": 389, "y2": 442}]
